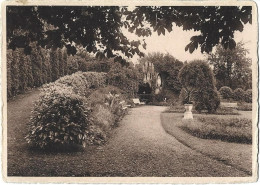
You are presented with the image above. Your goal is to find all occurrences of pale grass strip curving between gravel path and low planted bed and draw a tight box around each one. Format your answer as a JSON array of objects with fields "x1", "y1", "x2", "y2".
[{"x1": 161, "y1": 112, "x2": 252, "y2": 175}]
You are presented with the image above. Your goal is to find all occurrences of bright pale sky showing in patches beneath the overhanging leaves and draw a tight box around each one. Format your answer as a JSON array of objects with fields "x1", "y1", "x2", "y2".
[{"x1": 124, "y1": 24, "x2": 256, "y2": 63}]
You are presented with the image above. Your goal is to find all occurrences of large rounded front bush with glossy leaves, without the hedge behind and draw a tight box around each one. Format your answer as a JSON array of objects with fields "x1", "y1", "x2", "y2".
[{"x1": 26, "y1": 84, "x2": 90, "y2": 148}]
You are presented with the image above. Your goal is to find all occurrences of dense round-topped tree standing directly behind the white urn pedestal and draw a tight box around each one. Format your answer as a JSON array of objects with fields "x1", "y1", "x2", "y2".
[{"x1": 179, "y1": 60, "x2": 220, "y2": 113}]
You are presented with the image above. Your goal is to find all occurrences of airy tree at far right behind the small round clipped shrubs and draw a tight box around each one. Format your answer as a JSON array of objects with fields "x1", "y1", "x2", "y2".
[{"x1": 208, "y1": 42, "x2": 252, "y2": 90}]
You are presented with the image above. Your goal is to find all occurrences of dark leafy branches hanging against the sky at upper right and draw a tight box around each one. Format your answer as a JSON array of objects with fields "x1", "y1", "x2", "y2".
[{"x1": 125, "y1": 6, "x2": 252, "y2": 53}]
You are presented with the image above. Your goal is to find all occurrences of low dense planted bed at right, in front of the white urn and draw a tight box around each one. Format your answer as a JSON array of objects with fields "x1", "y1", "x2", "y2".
[{"x1": 180, "y1": 115, "x2": 252, "y2": 144}]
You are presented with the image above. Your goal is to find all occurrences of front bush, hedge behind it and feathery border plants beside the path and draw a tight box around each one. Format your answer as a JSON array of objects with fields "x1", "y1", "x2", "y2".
[{"x1": 26, "y1": 72, "x2": 126, "y2": 148}]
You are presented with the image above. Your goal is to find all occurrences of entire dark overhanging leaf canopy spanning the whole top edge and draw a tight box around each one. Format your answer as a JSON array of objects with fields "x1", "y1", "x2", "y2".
[{"x1": 6, "y1": 6, "x2": 252, "y2": 57}]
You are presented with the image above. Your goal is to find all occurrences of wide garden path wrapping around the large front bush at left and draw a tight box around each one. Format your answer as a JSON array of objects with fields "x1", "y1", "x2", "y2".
[{"x1": 7, "y1": 90, "x2": 247, "y2": 177}]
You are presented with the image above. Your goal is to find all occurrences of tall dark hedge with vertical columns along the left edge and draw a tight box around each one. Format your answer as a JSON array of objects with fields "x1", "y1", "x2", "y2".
[{"x1": 7, "y1": 45, "x2": 69, "y2": 99}]
